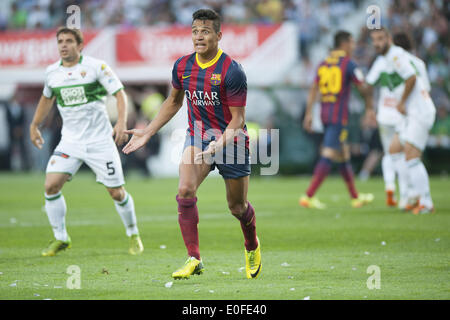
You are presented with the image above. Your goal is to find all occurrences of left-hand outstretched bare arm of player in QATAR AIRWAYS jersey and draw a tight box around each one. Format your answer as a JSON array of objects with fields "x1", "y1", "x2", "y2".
[{"x1": 122, "y1": 88, "x2": 184, "y2": 154}]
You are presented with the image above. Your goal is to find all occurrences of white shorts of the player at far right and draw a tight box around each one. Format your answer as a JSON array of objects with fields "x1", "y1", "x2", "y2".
[{"x1": 399, "y1": 114, "x2": 434, "y2": 151}]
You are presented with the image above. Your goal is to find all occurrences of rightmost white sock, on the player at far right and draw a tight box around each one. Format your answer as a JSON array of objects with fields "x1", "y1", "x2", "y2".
[{"x1": 406, "y1": 158, "x2": 433, "y2": 208}]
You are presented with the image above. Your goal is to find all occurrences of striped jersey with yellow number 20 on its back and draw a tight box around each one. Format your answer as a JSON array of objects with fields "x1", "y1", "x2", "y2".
[{"x1": 315, "y1": 50, "x2": 364, "y2": 126}]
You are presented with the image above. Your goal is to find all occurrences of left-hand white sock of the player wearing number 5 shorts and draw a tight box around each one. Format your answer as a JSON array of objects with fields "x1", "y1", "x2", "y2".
[{"x1": 45, "y1": 191, "x2": 69, "y2": 241}]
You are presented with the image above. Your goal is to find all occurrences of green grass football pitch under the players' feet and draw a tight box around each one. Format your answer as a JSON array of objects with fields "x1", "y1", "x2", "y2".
[{"x1": 0, "y1": 172, "x2": 450, "y2": 300}]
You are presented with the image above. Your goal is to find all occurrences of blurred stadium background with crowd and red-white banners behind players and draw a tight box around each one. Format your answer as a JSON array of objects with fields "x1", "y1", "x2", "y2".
[{"x1": 0, "y1": 0, "x2": 450, "y2": 179}]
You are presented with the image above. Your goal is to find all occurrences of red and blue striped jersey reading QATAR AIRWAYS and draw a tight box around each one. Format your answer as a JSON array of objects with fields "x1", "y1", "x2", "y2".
[{"x1": 172, "y1": 49, "x2": 248, "y2": 148}]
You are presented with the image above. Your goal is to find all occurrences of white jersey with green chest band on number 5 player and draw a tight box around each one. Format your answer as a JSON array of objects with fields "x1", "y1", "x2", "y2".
[{"x1": 43, "y1": 56, "x2": 123, "y2": 143}]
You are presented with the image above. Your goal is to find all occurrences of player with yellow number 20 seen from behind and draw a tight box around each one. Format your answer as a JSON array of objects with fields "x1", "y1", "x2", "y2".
[{"x1": 299, "y1": 31, "x2": 375, "y2": 209}]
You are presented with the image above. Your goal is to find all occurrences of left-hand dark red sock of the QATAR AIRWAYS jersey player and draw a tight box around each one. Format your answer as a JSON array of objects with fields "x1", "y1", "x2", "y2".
[{"x1": 176, "y1": 195, "x2": 200, "y2": 260}]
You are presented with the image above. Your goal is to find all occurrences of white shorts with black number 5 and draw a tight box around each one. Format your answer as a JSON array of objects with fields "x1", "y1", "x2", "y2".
[{"x1": 46, "y1": 138, "x2": 125, "y2": 188}]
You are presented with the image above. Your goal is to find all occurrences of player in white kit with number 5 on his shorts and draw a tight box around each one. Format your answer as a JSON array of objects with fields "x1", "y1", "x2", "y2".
[{"x1": 30, "y1": 27, "x2": 144, "y2": 256}]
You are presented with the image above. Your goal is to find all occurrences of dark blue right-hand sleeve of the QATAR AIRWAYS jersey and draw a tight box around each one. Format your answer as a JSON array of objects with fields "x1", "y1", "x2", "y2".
[{"x1": 225, "y1": 61, "x2": 247, "y2": 107}]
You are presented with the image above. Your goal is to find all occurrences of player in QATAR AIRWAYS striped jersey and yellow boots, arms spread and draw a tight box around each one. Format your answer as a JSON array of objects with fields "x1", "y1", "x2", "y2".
[{"x1": 123, "y1": 9, "x2": 261, "y2": 279}]
